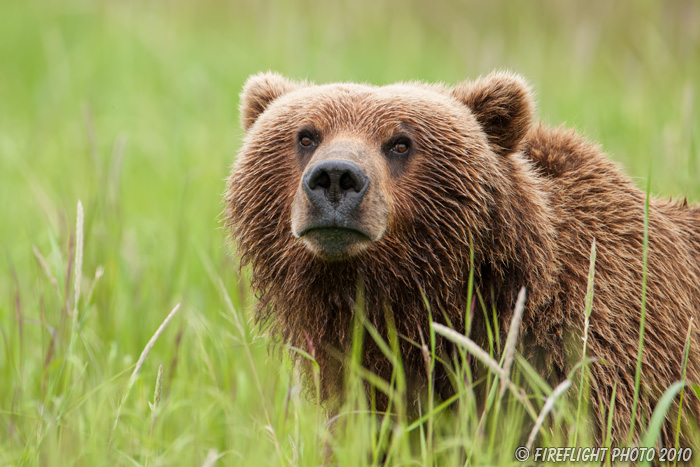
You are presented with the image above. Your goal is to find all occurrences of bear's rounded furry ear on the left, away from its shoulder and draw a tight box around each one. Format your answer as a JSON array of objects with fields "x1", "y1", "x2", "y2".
[{"x1": 241, "y1": 72, "x2": 301, "y2": 131}]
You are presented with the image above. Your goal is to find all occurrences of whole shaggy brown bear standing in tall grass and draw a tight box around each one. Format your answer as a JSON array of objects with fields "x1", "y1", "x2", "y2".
[{"x1": 225, "y1": 72, "x2": 700, "y2": 446}]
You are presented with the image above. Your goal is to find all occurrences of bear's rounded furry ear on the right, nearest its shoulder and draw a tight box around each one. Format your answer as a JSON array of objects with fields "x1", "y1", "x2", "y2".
[{"x1": 452, "y1": 71, "x2": 534, "y2": 155}]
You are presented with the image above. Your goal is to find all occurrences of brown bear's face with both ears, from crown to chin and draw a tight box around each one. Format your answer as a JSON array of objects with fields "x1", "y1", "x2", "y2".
[{"x1": 231, "y1": 73, "x2": 532, "y2": 262}]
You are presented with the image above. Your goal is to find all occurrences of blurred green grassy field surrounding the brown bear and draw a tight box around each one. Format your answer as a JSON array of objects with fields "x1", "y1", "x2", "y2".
[{"x1": 0, "y1": 0, "x2": 700, "y2": 465}]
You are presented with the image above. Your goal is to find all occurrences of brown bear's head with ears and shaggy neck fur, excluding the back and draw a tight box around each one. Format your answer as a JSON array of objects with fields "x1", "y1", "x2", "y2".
[{"x1": 225, "y1": 72, "x2": 555, "y2": 402}]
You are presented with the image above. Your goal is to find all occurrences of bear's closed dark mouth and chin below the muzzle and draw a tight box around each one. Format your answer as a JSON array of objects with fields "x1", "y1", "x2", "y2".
[{"x1": 299, "y1": 226, "x2": 372, "y2": 261}]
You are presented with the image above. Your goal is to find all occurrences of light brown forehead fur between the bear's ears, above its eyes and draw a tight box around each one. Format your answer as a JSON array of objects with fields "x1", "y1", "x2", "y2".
[{"x1": 279, "y1": 83, "x2": 469, "y2": 132}]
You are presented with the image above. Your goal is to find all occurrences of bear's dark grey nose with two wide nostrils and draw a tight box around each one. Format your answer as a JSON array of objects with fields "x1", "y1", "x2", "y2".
[{"x1": 303, "y1": 159, "x2": 369, "y2": 209}]
